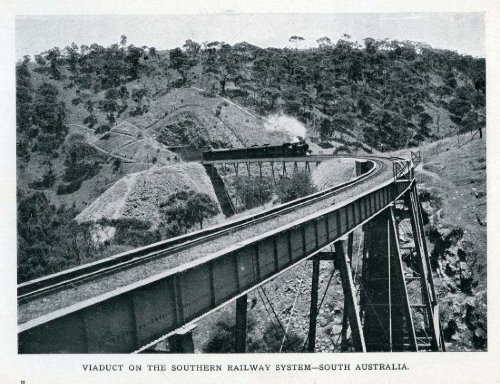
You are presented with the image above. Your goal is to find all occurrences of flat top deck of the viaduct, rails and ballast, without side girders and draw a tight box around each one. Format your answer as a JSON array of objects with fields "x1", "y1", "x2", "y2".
[{"x1": 17, "y1": 155, "x2": 404, "y2": 324}]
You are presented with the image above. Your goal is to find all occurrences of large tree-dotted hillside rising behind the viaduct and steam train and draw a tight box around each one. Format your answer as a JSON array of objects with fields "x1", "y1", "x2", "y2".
[{"x1": 16, "y1": 38, "x2": 486, "y2": 310}]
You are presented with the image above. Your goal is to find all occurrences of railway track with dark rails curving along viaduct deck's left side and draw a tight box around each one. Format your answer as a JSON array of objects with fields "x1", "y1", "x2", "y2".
[{"x1": 18, "y1": 156, "x2": 398, "y2": 322}]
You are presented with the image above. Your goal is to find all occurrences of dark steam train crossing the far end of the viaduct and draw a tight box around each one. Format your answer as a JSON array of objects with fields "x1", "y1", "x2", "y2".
[{"x1": 203, "y1": 140, "x2": 312, "y2": 161}]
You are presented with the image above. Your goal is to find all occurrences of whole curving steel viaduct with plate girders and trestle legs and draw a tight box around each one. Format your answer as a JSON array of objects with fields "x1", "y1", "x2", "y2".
[{"x1": 18, "y1": 153, "x2": 444, "y2": 353}]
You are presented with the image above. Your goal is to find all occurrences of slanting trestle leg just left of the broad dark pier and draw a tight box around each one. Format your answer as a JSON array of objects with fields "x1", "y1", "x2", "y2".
[{"x1": 335, "y1": 241, "x2": 366, "y2": 352}]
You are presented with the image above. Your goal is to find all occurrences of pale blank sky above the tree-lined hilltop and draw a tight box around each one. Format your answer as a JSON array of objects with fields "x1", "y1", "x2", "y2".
[{"x1": 15, "y1": 12, "x2": 485, "y2": 59}]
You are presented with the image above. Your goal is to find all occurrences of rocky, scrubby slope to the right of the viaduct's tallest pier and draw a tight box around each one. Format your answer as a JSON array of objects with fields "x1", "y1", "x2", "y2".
[{"x1": 392, "y1": 135, "x2": 487, "y2": 351}]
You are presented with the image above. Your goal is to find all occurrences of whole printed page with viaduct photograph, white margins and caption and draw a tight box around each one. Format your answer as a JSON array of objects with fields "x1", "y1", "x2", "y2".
[{"x1": 3, "y1": 0, "x2": 498, "y2": 384}]
